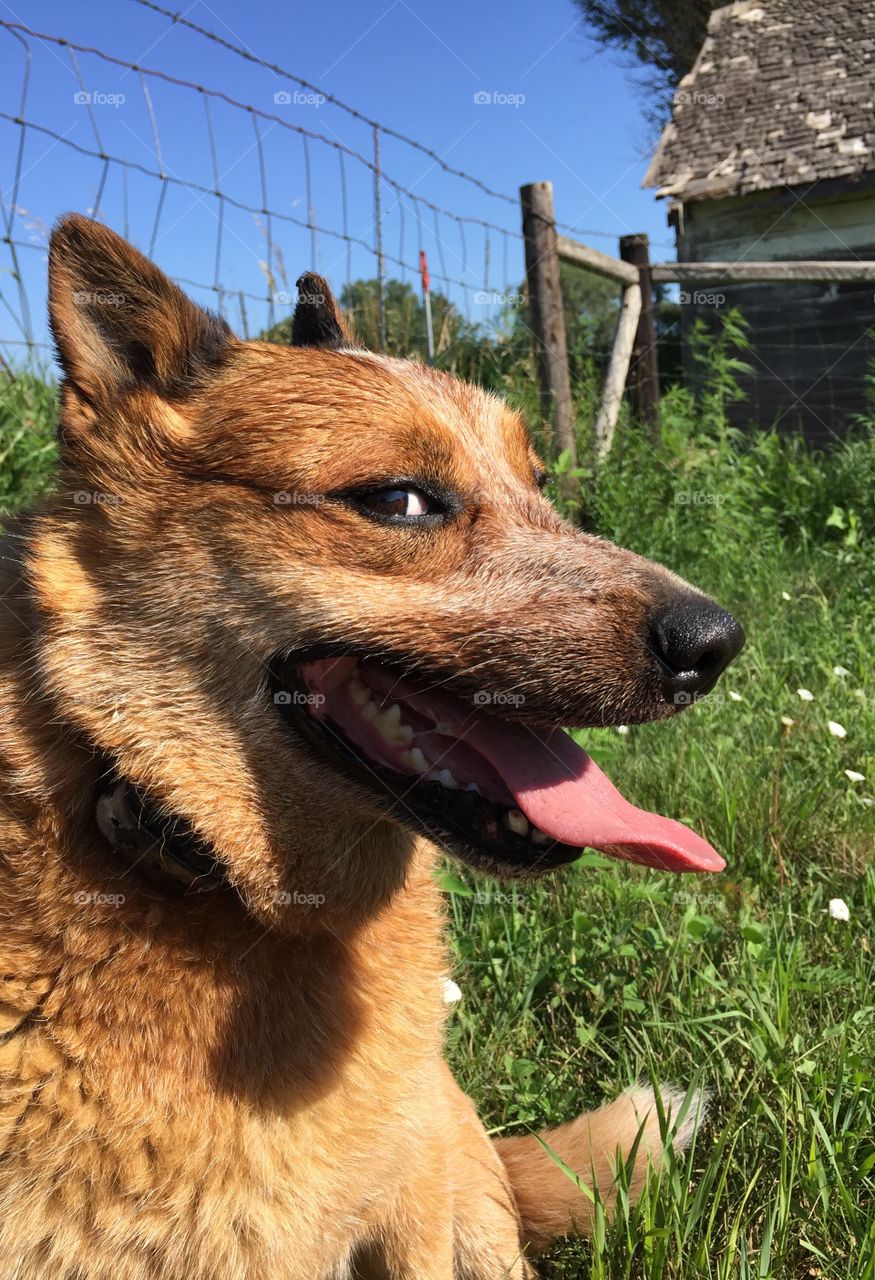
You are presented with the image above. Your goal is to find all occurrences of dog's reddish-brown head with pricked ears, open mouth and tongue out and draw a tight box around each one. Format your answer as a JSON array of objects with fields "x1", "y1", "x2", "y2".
[{"x1": 29, "y1": 216, "x2": 743, "y2": 919}]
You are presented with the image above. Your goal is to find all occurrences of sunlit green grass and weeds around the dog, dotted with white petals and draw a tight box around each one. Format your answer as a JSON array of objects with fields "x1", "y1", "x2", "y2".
[{"x1": 0, "y1": 349, "x2": 875, "y2": 1280}]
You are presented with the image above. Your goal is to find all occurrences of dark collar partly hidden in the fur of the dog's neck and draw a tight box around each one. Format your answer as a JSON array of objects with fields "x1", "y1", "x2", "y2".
[{"x1": 97, "y1": 778, "x2": 228, "y2": 893}]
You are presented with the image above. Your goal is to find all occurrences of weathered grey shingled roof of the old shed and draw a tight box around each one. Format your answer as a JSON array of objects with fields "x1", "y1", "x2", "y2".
[{"x1": 643, "y1": 0, "x2": 875, "y2": 200}]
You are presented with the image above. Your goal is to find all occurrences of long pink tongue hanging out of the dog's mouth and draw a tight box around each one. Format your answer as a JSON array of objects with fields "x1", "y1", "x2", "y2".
[{"x1": 464, "y1": 714, "x2": 725, "y2": 872}]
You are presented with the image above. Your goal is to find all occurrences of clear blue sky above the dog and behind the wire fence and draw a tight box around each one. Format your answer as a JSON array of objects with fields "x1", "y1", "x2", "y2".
[{"x1": 0, "y1": 0, "x2": 673, "y2": 356}]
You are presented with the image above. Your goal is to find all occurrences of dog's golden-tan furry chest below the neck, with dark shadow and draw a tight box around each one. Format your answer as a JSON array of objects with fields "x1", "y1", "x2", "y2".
[{"x1": 0, "y1": 890, "x2": 441, "y2": 1280}]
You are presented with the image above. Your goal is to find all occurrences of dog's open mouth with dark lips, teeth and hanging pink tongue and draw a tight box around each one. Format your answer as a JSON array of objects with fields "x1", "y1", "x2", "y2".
[{"x1": 271, "y1": 655, "x2": 724, "y2": 876}]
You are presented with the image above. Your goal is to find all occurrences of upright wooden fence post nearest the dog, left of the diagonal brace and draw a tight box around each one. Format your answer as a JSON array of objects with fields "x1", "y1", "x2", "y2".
[{"x1": 519, "y1": 182, "x2": 577, "y2": 478}]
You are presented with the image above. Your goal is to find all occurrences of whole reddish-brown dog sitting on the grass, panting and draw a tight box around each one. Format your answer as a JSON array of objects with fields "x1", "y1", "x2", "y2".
[{"x1": 0, "y1": 216, "x2": 742, "y2": 1280}]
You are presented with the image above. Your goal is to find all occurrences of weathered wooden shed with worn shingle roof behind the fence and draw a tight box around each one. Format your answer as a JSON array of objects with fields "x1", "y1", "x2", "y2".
[{"x1": 645, "y1": 0, "x2": 875, "y2": 443}]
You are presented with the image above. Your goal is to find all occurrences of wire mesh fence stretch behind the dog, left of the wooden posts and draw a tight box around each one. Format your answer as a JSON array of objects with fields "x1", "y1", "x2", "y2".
[{"x1": 0, "y1": 10, "x2": 634, "y2": 371}]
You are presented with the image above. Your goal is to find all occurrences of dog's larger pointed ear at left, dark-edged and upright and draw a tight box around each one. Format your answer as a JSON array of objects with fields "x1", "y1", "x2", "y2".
[{"x1": 49, "y1": 214, "x2": 233, "y2": 406}]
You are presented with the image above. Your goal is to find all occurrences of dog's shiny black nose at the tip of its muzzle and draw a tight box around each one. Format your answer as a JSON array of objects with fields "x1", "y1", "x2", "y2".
[{"x1": 650, "y1": 595, "x2": 745, "y2": 707}]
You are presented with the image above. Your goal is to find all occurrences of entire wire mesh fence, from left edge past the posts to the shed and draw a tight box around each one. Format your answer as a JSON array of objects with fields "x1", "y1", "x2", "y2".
[{"x1": 8, "y1": 0, "x2": 871, "y2": 453}]
